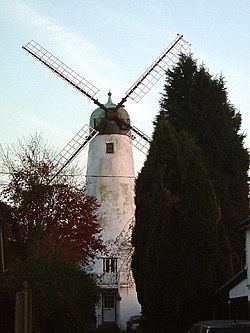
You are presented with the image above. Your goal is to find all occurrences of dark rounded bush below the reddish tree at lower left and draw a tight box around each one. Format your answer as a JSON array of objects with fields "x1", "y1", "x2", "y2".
[{"x1": 1, "y1": 256, "x2": 99, "y2": 333}]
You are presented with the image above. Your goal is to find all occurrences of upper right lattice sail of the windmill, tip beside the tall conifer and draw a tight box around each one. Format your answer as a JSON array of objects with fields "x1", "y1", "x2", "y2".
[{"x1": 119, "y1": 35, "x2": 190, "y2": 104}]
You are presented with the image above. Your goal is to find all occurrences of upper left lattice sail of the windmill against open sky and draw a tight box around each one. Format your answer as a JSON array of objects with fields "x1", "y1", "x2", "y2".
[{"x1": 22, "y1": 40, "x2": 99, "y2": 99}]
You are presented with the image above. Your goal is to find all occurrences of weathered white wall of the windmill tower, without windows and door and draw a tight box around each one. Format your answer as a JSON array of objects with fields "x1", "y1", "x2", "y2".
[{"x1": 87, "y1": 134, "x2": 140, "y2": 330}]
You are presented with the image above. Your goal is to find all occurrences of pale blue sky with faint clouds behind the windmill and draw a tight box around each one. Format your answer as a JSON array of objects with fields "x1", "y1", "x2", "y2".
[{"x1": 0, "y1": 0, "x2": 250, "y2": 172}]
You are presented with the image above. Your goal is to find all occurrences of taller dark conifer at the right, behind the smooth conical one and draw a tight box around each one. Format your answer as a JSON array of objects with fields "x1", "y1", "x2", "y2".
[{"x1": 161, "y1": 56, "x2": 249, "y2": 270}]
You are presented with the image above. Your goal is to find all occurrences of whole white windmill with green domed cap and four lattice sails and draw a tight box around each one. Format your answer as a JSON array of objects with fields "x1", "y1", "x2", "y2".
[{"x1": 23, "y1": 35, "x2": 189, "y2": 329}]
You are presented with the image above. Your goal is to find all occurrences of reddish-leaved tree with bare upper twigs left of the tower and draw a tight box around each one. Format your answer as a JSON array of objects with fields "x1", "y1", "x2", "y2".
[{"x1": 3, "y1": 136, "x2": 102, "y2": 263}]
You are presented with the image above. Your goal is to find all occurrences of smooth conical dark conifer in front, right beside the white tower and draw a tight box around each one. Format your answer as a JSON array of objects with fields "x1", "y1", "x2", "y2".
[{"x1": 132, "y1": 113, "x2": 230, "y2": 333}]
